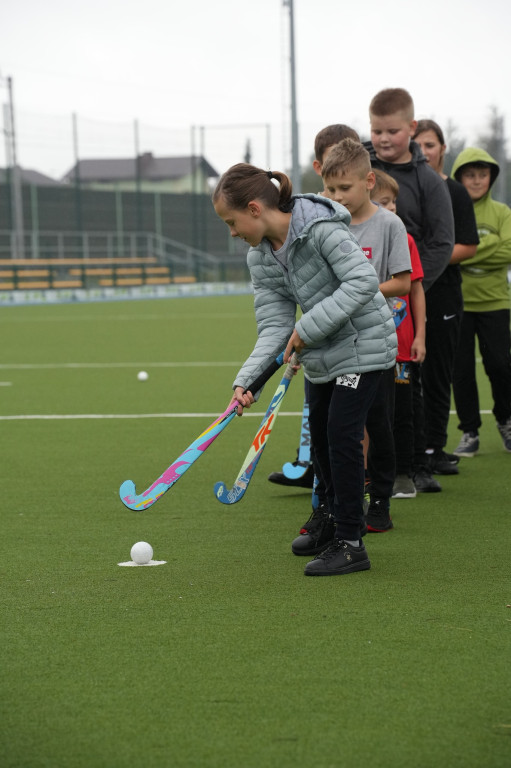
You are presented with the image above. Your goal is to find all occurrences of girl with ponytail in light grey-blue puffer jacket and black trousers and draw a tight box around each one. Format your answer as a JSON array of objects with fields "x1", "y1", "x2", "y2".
[{"x1": 213, "y1": 163, "x2": 397, "y2": 576}]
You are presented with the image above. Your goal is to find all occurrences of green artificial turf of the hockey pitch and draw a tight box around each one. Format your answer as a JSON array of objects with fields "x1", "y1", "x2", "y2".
[{"x1": 0, "y1": 296, "x2": 511, "y2": 768}]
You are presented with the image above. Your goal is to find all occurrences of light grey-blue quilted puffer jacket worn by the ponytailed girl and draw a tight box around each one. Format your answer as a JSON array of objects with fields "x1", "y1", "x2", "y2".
[{"x1": 233, "y1": 194, "x2": 397, "y2": 394}]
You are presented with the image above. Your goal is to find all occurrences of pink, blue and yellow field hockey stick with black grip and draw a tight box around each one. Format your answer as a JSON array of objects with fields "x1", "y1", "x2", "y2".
[{"x1": 119, "y1": 352, "x2": 284, "y2": 511}]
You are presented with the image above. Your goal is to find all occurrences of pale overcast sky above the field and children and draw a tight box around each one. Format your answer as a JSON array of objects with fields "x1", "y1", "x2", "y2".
[{"x1": 0, "y1": 0, "x2": 511, "y2": 178}]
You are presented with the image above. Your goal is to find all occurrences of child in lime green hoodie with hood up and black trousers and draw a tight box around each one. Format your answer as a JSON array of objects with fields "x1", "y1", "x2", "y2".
[{"x1": 451, "y1": 147, "x2": 511, "y2": 457}]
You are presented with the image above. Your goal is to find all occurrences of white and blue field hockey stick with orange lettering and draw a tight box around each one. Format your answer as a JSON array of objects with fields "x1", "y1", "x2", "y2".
[{"x1": 214, "y1": 356, "x2": 296, "y2": 504}]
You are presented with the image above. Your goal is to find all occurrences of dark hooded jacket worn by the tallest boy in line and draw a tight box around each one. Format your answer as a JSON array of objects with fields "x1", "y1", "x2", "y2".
[{"x1": 364, "y1": 141, "x2": 454, "y2": 291}]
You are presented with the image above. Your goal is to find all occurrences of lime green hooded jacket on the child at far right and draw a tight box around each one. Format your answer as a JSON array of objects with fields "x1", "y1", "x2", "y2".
[{"x1": 451, "y1": 147, "x2": 511, "y2": 312}]
